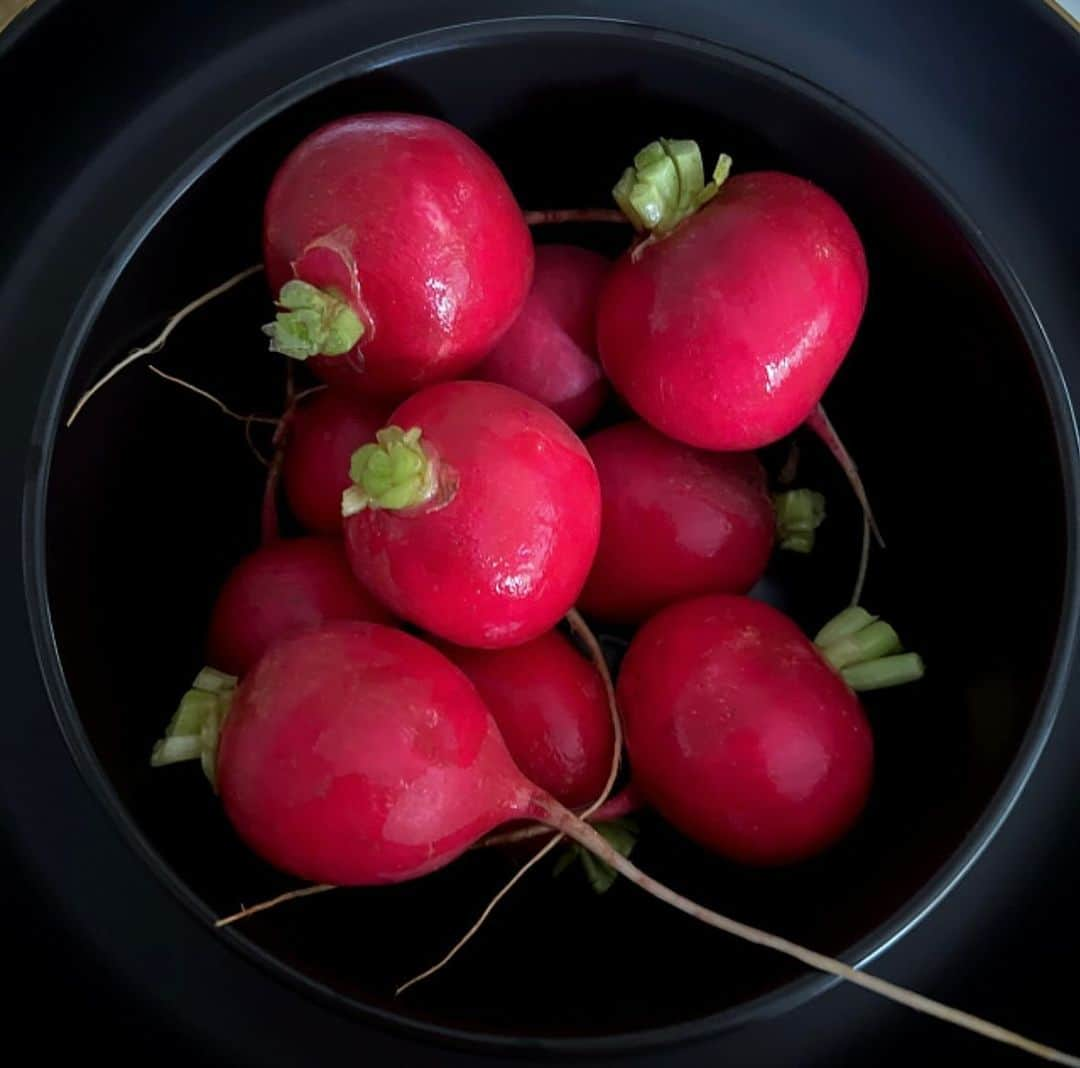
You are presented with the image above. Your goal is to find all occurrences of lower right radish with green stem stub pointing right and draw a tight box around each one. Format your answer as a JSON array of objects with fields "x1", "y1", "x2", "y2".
[{"x1": 618, "y1": 595, "x2": 922, "y2": 864}]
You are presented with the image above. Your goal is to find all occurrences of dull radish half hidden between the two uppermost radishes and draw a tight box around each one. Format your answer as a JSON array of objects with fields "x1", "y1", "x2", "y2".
[{"x1": 474, "y1": 245, "x2": 611, "y2": 430}]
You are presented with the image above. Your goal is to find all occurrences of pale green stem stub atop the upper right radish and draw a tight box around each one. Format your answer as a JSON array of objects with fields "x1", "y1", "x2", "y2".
[{"x1": 611, "y1": 137, "x2": 731, "y2": 235}]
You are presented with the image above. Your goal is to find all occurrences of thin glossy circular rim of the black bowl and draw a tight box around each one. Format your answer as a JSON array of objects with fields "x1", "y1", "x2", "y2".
[{"x1": 22, "y1": 15, "x2": 1080, "y2": 1055}]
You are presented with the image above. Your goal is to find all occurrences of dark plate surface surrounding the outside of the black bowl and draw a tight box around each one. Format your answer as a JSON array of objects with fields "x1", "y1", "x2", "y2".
[{"x1": 0, "y1": 0, "x2": 1080, "y2": 1066}]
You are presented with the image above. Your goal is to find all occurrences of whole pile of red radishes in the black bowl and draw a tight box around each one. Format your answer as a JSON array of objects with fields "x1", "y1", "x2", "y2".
[{"x1": 107, "y1": 113, "x2": 1072, "y2": 1063}]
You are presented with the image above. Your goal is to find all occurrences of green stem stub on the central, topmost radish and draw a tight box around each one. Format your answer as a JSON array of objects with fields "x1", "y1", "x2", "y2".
[{"x1": 341, "y1": 427, "x2": 438, "y2": 518}]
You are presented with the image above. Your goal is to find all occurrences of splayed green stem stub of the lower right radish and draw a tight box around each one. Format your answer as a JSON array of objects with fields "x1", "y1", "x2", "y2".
[{"x1": 814, "y1": 605, "x2": 926, "y2": 691}]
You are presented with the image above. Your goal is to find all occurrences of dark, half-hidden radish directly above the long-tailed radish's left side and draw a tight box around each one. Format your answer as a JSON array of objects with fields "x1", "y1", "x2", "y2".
[{"x1": 206, "y1": 538, "x2": 392, "y2": 675}]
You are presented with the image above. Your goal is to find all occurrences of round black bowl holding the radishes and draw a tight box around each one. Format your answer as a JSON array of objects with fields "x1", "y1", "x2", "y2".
[{"x1": 21, "y1": 19, "x2": 1077, "y2": 1051}]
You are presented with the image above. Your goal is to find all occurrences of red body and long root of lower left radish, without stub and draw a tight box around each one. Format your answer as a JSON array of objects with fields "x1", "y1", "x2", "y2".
[{"x1": 156, "y1": 623, "x2": 1080, "y2": 1066}]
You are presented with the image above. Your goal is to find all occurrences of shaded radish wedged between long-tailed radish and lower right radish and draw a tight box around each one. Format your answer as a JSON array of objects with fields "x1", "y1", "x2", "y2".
[{"x1": 442, "y1": 631, "x2": 615, "y2": 808}]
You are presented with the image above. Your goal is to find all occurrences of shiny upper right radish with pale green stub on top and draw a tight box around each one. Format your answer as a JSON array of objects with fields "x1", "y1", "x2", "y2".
[{"x1": 597, "y1": 141, "x2": 867, "y2": 451}]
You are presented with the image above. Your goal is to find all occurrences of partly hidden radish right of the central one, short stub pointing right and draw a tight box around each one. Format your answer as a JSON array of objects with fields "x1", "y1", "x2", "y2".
[{"x1": 578, "y1": 420, "x2": 824, "y2": 623}]
